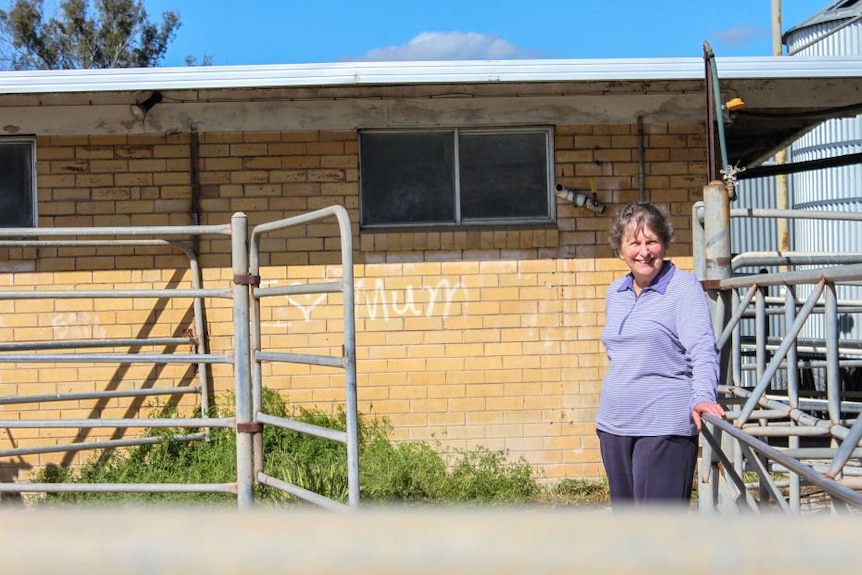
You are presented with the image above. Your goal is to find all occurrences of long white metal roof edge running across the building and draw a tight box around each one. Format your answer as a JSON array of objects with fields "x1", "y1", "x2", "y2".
[{"x1": 0, "y1": 56, "x2": 862, "y2": 94}]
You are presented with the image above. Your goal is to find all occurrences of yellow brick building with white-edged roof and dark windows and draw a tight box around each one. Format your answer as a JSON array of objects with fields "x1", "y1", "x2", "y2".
[{"x1": 0, "y1": 58, "x2": 862, "y2": 480}]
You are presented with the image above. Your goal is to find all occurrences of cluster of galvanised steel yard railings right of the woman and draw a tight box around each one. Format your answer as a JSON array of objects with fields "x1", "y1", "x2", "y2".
[{"x1": 692, "y1": 184, "x2": 862, "y2": 513}]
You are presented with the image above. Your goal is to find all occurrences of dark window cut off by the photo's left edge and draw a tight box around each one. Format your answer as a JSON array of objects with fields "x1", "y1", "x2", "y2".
[{"x1": 0, "y1": 139, "x2": 36, "y2": 228}]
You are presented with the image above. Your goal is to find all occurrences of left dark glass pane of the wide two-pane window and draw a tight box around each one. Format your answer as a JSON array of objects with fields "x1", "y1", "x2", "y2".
[{"x1": 360, "y1": 132, "x2": 455, "y2": 225}]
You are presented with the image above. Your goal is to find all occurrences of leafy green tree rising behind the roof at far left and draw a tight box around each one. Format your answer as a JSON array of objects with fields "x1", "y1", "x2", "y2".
[{"x1": 0, "y1": 0, "x2": 180, "y2": 70}]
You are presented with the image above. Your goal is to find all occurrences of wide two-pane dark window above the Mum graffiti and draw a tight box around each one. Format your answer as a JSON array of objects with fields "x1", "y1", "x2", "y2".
[{"x1": 359, "y1": 128, "x2": 554, "y2": 227}]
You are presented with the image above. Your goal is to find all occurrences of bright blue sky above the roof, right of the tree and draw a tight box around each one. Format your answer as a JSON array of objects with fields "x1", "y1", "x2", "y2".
[{"x1": 144, "y1": 0, "x2": 834, "y2": 66}]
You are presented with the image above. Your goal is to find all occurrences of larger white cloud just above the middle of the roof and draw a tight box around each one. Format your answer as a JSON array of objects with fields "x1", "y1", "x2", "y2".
[{"x1": 349, "y1": 32, "x2": 536, "y2": 62}]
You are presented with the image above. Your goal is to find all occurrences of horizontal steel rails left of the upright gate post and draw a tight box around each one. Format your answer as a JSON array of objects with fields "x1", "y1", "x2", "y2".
[{"x1": 0, "y1": 220, "x2": 235, "y2": 500}]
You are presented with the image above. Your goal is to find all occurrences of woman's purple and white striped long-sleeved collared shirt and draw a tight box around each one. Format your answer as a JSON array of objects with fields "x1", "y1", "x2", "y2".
[{"x1": 596, "y1": 261, "x2": 718, "y2": 436}]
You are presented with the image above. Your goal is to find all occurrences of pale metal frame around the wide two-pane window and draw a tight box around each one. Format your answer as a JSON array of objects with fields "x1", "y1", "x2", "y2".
[{"x1": 357, "y1": 126, "x2": 557, "y2": 230}]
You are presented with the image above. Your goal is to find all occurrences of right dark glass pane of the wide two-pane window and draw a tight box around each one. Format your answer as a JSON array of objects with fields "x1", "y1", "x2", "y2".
[{"x1": 458, "y1": 132, "x2": 549, "y2": 219}]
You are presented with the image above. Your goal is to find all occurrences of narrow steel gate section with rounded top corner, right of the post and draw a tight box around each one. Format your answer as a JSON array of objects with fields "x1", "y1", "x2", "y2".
[{"x1": 248, "y1": 206, "x2": 359, "y2": 510}]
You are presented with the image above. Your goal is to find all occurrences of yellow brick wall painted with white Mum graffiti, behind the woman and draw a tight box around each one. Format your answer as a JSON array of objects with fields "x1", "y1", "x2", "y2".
[{"x1": 0, "y1": 124, "x2": 706, "y2": 486}]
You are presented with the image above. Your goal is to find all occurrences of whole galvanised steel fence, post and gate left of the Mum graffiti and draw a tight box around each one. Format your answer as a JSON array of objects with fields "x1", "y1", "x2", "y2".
[{"x1": 0, "y1": 206, "x2": 359, "y2": 510}]
